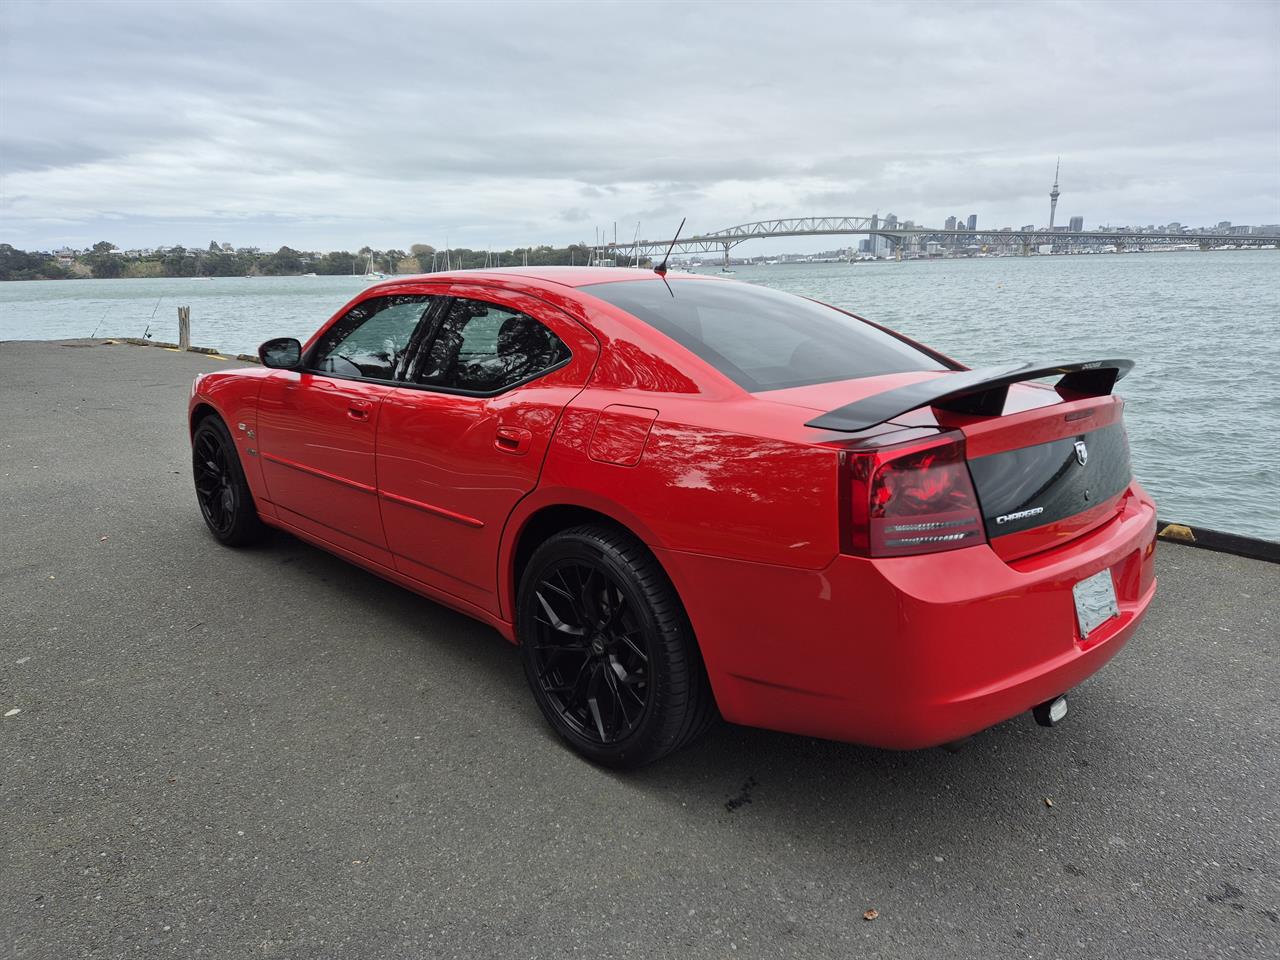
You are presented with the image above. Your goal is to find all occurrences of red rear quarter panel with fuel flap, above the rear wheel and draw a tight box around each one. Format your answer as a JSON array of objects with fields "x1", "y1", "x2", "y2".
[{"x1": 499, "y1": 289, "x2": 840, "y2": 611}]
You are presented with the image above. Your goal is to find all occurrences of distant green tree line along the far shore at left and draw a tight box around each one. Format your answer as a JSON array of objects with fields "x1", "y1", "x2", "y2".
[{"x1": 0, "y1": 241, "x2": 648, "y2": 280}]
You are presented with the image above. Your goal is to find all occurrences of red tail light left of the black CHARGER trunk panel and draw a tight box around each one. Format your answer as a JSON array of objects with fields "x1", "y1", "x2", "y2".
[{"x1": 841, "y1": 434, "x2": 987, "y2": 557}]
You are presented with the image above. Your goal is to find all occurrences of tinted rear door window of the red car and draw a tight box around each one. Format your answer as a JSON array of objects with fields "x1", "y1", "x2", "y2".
[{"x1": 413, "y1": 300, "x2": 568, "y2": 393}]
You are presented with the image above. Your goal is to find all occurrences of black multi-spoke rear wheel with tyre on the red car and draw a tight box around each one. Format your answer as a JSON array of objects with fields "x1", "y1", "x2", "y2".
[{"x1": 516, "y1": 525, "x2": 716, "y2": 767}]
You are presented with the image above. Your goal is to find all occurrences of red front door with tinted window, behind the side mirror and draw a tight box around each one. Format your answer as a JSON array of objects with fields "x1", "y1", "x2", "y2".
[{"x1": 257, "y1": 296, "x2": 434, "y2": 567}]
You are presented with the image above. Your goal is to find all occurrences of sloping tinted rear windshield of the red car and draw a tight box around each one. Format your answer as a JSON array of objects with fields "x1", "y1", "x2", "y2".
[{"x1": 585, "y1": 279, "x2": 947, "y2": 392}]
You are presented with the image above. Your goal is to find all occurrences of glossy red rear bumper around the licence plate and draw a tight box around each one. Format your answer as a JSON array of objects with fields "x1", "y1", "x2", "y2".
[{"x1": 657, "y1": 484, "x2": 1156, "y2": 749}]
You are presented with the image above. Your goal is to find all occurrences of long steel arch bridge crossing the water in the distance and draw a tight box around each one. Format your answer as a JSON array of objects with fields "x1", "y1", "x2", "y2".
[{"x1": 602, "y1": 216, "x2": 1280, "y2": 262}]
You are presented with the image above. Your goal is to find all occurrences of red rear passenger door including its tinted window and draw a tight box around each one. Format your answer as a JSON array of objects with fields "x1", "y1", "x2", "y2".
[{"x1": 376, "y1": 284, "x2": 598, "y2": 612}]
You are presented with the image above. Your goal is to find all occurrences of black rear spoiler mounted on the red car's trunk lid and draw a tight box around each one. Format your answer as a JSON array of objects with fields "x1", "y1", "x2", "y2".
[{"x1": 805, "y1": 360, "x2": 1133, "y2": 433}]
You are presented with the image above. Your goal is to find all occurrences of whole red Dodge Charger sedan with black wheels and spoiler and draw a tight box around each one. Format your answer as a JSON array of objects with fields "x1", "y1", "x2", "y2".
[{"x1": 189, "y1": 268, "x2": 1156, "y2": 767}]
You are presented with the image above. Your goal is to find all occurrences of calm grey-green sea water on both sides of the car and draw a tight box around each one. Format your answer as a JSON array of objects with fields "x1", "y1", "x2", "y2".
[{"x1": 0, "y1": 251, "x2": 1280, "y2": 540}]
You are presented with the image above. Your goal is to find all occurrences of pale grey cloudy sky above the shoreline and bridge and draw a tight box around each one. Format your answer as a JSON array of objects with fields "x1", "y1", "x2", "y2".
[{"x1": 0, "y1": 0, "x2": 1280, "y2": 252}]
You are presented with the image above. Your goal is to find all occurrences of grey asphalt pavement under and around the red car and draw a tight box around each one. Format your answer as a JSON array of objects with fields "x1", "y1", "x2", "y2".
[{"x1": 0, "y1": 342, "x2": 1280, "y2": 960}]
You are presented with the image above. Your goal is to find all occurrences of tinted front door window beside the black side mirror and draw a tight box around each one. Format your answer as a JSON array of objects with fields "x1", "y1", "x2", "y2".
[{"x1": 311, "y1": 296, "x2": 435, "y2": 380}]
